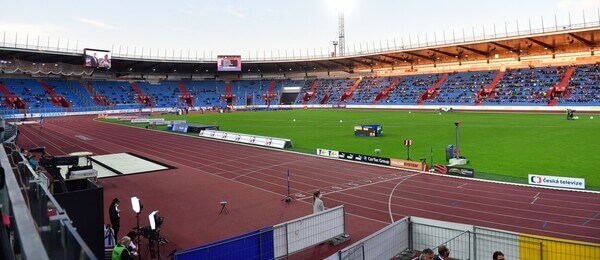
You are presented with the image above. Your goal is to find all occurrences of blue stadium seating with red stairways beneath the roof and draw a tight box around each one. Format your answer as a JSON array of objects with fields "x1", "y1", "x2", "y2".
[{"x1": 0, "y1": 64, "x2": 600, "y2": 110}]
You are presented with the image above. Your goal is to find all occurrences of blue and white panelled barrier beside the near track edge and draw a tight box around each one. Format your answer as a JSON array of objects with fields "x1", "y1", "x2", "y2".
[{"x1": 175, "y1": 205, "x2": 346, "y2": 260}]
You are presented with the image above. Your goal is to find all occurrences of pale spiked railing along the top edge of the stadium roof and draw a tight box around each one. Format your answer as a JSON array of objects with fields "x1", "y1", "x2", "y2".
[{"x1": 0, "y1": 18, "x2": 600, "y2": 62}]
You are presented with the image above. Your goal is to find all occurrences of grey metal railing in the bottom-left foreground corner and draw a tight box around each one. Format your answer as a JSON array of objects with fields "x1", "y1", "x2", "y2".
[{"x1": 0, "y1": 143, "x2": 96, "y2": 259}]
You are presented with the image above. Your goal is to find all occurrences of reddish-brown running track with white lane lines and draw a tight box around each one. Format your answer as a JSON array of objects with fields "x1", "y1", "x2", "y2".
[{"x1": 19, "y1": 117, "x2": 600, "y2": 258}]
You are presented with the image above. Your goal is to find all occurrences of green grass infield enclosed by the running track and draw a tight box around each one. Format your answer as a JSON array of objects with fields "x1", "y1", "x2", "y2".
[{"x1": 109, "y1": 110, "x2": 600, "y2": 190}]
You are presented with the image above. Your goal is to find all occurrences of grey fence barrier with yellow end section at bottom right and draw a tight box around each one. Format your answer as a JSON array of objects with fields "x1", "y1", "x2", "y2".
[{"x1": 327, "y1": 217, "x2": 600, "y2": 260}]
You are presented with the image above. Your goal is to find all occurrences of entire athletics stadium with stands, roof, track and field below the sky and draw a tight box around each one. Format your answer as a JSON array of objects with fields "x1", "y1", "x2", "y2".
[{"x1": 0, "y1": 2, "x2": 600, "y2": 259}]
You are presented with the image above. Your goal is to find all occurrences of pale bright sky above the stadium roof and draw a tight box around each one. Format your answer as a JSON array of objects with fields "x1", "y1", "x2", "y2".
[{"x1": 0, "y1": 0, "x2": 600, "y2": 58}]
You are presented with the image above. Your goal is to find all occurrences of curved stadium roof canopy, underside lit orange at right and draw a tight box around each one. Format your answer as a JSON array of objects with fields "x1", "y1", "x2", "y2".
[{"x1": 0, "y1": 23, "x2": 600, "y2": 75}]
